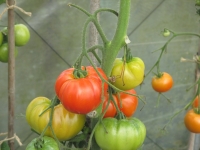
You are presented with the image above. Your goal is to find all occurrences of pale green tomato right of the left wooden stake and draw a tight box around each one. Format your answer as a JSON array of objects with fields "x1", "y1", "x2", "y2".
[{"x1": 15, "y1": 24, "x2": 30, "y2": 46}]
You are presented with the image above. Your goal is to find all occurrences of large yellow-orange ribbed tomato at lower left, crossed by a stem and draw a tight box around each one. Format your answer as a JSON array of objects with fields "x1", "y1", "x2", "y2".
[{"x1": 26, "y1": 97, "x2": 86, "y2": 141}]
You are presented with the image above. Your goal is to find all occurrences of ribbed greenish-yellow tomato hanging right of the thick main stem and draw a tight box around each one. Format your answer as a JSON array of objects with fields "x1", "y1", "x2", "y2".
[{"x1": 111, "y1": 57, "x2": 145, "y2": 91}]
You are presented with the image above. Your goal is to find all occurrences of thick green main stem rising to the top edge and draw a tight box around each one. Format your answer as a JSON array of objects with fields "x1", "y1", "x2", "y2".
[{"x1": 102, "y1": 0, "x2": 131, "y2": 76}]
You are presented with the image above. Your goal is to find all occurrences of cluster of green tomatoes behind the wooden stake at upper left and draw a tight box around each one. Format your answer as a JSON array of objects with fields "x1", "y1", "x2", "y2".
[{"x1": 0, "y1": 24, "x2": 30, "y2": 63}]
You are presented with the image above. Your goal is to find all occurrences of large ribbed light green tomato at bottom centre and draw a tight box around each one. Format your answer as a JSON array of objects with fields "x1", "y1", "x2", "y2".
[{"x1": 94, "y1": 118, "x2": 146, "y2": 150}]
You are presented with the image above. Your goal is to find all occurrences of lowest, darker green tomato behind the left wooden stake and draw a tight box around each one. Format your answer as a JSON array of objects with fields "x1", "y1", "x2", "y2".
[{"x1": 0, "y1": 43, "x2": 18, "y2": 63}]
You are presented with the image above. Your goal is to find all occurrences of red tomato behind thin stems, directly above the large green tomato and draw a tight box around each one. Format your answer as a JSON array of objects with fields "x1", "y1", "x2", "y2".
[{"x1": 103, "y1": 89, "x2": 138, "y2": 118}]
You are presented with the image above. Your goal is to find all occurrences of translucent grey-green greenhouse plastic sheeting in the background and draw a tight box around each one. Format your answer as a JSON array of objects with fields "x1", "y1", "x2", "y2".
[{"x1": 0, "y1": 0, "x2": 200, "y2": 150}]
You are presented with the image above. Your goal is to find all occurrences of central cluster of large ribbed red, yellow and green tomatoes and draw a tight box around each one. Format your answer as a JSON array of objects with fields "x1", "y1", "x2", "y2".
[{"x1": 26, "y1": 54, "x2": 146, "y2": 150}]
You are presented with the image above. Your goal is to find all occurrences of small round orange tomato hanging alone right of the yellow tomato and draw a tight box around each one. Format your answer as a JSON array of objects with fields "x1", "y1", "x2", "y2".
[{"x1": 151, "y1": 72, "x2": 173, "y2": 93}]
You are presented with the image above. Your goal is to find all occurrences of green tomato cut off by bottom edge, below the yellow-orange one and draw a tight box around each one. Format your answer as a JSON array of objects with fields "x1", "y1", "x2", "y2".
[{"x1": 26, "y1": 136, "x2": 59, "y2": 150}]
